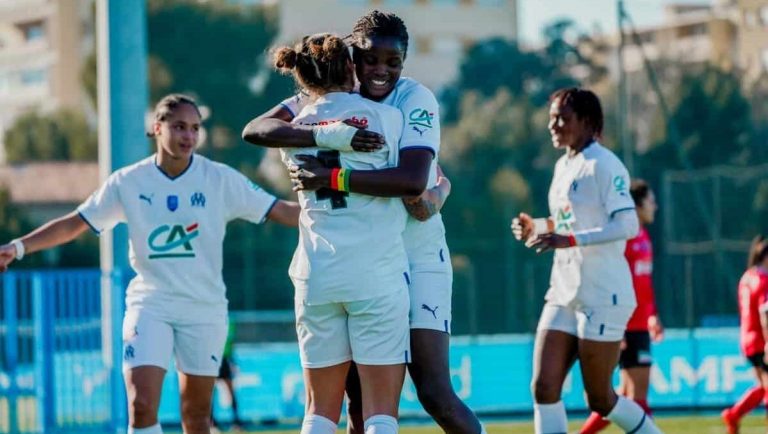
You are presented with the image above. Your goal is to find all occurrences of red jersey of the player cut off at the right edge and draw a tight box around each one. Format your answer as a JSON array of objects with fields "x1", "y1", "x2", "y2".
[{"x1": 739, "y1": 267, "x2": 768, "y2": 356}]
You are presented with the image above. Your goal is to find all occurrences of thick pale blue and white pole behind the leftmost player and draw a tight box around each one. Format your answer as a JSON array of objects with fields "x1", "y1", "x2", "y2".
[{"x1": 96, "y1": 0, "x2": 148, "y2": 433}]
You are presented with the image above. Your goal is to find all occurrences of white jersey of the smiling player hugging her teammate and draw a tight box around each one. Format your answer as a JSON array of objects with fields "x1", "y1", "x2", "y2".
[{"x1": 282, "y1": 77, "x2": 450, "y2": 271}]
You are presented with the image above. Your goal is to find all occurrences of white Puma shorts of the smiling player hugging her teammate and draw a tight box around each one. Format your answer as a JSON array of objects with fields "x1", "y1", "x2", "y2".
[{"x1": 408, "y1": 269, "x2": 453, "y2": 333}]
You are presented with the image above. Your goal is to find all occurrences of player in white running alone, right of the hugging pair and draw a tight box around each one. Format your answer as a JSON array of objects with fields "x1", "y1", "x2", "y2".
[{"x1": 512, "y1": 88, "x2": 660, "y2": 434}]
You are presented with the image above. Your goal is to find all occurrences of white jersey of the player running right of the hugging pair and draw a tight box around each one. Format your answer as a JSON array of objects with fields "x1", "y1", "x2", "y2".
[{"x1": 546, "y1": 142, "x2": 636, "y2": 308}]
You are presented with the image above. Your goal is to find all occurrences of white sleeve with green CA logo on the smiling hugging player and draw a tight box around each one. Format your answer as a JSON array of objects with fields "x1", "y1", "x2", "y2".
[{"x1": 398, "y1": 86, "x2": 440, "y2": 156}]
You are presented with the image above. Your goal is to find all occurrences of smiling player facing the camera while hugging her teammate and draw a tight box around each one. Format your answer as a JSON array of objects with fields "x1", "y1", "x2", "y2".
[{"x1": 243, "y1": 10, "x2": 484, "y2": 434}]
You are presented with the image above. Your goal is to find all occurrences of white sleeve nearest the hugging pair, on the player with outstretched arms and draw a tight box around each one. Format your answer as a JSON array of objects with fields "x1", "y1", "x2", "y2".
[{"x1": 224, "y1": 167, "x2": 277, "y2": 223}]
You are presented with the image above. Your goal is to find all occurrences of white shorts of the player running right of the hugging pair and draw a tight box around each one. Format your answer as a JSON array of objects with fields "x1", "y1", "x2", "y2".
[{"x1": 537, "y1": 303, "x2": 635, "y2": 342}]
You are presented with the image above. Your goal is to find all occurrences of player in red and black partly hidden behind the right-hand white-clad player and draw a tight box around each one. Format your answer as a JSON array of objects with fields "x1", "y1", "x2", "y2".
[{"x1": 581, "y1": 179, "x2": 664, "y2": 434}]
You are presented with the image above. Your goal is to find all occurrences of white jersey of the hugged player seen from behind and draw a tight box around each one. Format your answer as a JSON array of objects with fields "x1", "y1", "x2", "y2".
[{"x1": 281, "y1": 92, "x2": 408, "y2": 304}]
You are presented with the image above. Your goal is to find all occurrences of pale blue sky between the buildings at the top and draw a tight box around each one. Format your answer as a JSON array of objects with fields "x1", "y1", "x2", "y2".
[{"x1": 518, "y1": 0, "x2": 711, "y2": 43}]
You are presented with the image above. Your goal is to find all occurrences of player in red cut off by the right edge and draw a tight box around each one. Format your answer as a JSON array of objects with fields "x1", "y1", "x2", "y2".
[{"x1": 722, "y1": 236, "x2": 768, "y2": 434}]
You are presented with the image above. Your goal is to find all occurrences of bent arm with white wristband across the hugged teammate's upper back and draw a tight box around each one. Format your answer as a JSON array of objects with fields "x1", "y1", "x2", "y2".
[{"x1": 242, "y1": 104, "x2": 384, "y2": 152}]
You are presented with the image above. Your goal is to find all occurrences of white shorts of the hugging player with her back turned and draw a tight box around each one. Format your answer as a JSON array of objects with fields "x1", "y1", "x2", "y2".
[{"x1": 295, "y1": 282, "x2": 410, "y2": 368}]
